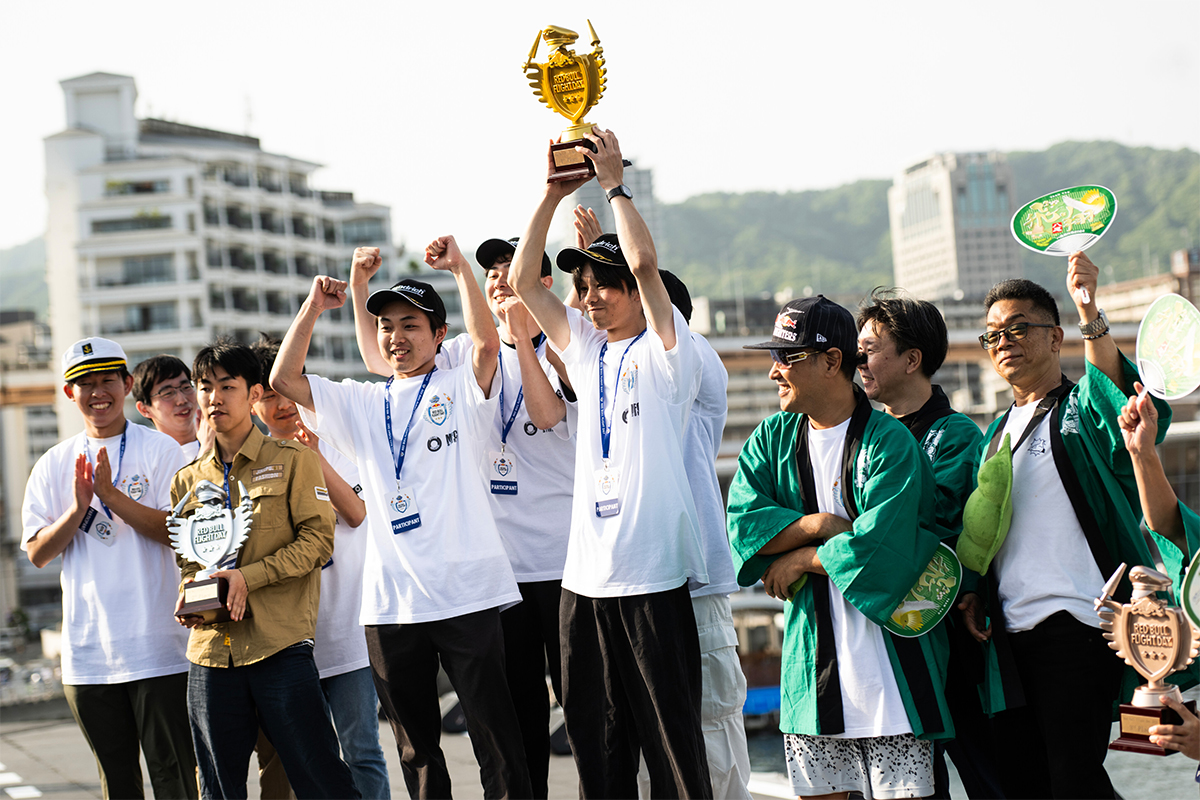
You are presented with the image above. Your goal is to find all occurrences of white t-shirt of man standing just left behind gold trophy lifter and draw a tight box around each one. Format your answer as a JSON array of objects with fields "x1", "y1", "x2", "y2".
[{"x1": 436, "y1": 333, "x2": 577, "y2": 583}]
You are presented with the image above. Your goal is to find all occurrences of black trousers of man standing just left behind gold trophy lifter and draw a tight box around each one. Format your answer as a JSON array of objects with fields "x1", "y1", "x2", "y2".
[{"x1": 500, "y1": 581, "x2": 563, "y2": 800}]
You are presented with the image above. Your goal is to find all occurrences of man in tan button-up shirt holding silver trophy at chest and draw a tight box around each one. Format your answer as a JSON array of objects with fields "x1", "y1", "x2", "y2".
[{"x1": 172, "y1": 338, "x2": 360, "y2": 798}]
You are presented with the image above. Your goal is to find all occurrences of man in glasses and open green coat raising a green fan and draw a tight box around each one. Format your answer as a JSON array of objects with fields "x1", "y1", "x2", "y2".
[{"x1": 964, "y1": 252, "x2": 1196, "y2": 798}]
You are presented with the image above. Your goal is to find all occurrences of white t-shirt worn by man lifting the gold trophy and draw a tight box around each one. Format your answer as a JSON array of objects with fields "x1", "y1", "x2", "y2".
[{"x1": 562, "y1": 308, "x2": 708, "y2": 597}]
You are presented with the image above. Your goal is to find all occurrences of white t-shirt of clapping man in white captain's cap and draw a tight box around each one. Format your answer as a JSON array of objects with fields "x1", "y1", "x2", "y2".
[{"x1": 20, "y1": 423, "x2": 187, "y2": 685}]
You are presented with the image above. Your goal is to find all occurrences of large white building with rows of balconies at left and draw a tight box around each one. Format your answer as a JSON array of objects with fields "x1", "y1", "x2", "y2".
[{"x1": 46, "y1": 72, "x2": 417, "y2": 435}]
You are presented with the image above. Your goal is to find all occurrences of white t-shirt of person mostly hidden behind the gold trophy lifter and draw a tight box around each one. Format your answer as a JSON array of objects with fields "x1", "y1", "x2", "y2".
[{"x1": 683, "y1": 333, "x2": 738, "y2": 597}]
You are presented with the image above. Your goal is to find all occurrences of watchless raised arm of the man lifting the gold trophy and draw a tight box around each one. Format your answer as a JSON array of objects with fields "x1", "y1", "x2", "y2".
[{"x1": 509, "y1": 141, "x2": 592, "y2": 350}]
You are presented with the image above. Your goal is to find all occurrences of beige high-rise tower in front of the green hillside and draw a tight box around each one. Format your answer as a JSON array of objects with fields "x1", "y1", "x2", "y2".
[{"x1": 888, "y1": 152, "x2": 1021, "y2": 300}]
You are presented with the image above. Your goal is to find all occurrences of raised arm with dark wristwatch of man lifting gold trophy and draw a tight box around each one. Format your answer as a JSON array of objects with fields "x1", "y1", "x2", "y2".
[{"x1": 588, "y1": 128, "x2": 676, "y2": 350}]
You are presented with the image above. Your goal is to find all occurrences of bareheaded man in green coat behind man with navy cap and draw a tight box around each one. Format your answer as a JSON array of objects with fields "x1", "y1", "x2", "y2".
[{"x1": 857, "y1": 289, "x2": 1001, "y2": 798}]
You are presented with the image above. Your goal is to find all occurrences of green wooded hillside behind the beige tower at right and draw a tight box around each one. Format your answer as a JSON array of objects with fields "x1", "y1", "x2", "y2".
[{"x1": 658, "y1": 142, "x2": 1200, "y2": 296}]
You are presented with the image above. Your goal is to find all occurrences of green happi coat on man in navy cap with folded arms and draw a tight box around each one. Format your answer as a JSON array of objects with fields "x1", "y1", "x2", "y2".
[{"x1": 728, "y1": 398, "x2": 953, "y2": 739}]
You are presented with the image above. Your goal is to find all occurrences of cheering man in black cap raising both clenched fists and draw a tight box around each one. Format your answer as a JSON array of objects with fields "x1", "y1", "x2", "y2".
[{"x1": 271, "y1": 247, "x2": 530, "y2": 798}]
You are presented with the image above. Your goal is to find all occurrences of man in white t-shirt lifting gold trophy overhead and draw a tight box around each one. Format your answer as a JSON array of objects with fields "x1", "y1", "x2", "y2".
[{"x1": 509, "y1": 128, "x2": 713, "y2": 798}]
